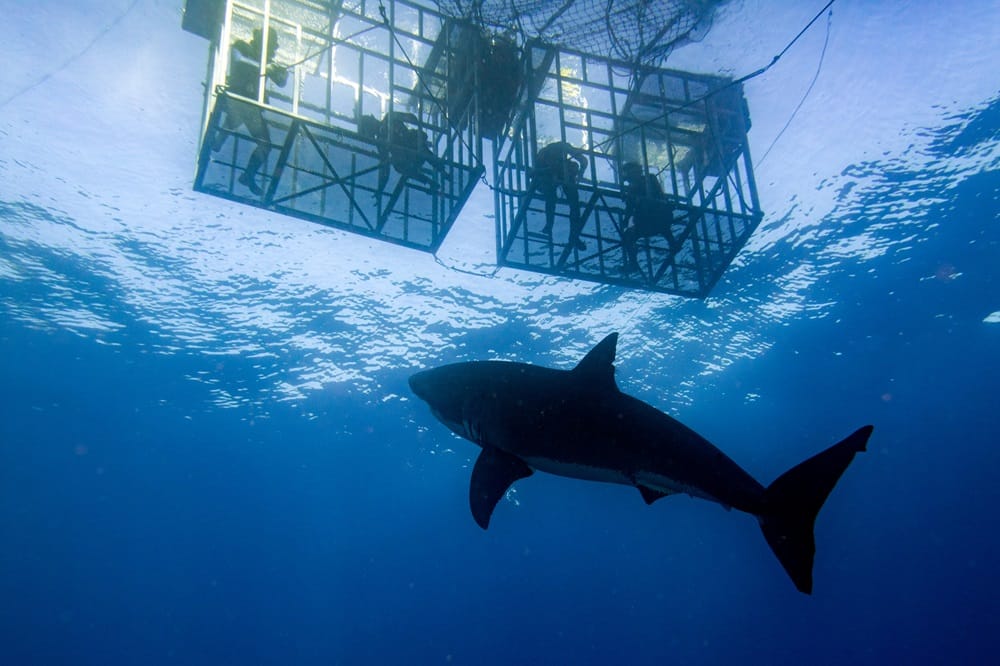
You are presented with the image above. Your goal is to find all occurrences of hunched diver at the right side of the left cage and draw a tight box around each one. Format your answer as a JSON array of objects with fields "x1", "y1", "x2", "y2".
[{"x1": 358, "y1": 111, "x2": 449, "y2": 196}]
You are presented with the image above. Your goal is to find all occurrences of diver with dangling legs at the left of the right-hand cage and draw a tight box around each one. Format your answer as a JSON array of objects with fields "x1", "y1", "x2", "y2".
[{"x1": 527, "y1": 141, "x2": 589, "y2": 250}]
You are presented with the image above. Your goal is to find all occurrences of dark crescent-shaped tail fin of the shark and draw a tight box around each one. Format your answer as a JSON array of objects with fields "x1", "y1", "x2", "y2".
[{"x1": 758, "y1": 426, "x2": 873, "y2": 594}]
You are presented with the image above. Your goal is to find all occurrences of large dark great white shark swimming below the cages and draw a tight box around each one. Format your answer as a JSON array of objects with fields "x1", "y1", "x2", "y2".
[{"x1": 410, "y1": 333, "x2": 873, "y2": 594}]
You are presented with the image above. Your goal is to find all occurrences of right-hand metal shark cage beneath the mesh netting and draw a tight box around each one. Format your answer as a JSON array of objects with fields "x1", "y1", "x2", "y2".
[{"x1": 493, "y1": 42, "x2": 762, "y2": 298}]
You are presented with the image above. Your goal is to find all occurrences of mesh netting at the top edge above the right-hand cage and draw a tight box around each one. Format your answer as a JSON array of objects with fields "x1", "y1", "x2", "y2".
[{"x1": 437, "y1": 0, "x2": 724, "y2": 64}]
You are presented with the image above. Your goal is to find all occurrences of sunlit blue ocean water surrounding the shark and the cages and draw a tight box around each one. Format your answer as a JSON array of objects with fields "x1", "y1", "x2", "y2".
[{"x1": 0, "y1": 0, "x2": 1000, "y2": 664}]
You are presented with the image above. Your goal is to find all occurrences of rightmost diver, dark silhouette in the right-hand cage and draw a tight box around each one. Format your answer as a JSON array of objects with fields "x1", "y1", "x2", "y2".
[{"x1": 621, "y1": 162, "x2": 677, "y2": 273}]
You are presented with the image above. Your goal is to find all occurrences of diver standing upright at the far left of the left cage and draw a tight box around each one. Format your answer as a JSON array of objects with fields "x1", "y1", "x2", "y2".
[{"x1": 212, "y1": 28, "x2": 288, "y2": 196}]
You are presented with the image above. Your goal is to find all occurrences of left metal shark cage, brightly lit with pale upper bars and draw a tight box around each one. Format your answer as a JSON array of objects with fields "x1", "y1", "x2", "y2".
[{"x1": 183, "y1": 0, "x2": 483, "y2": 251}]
